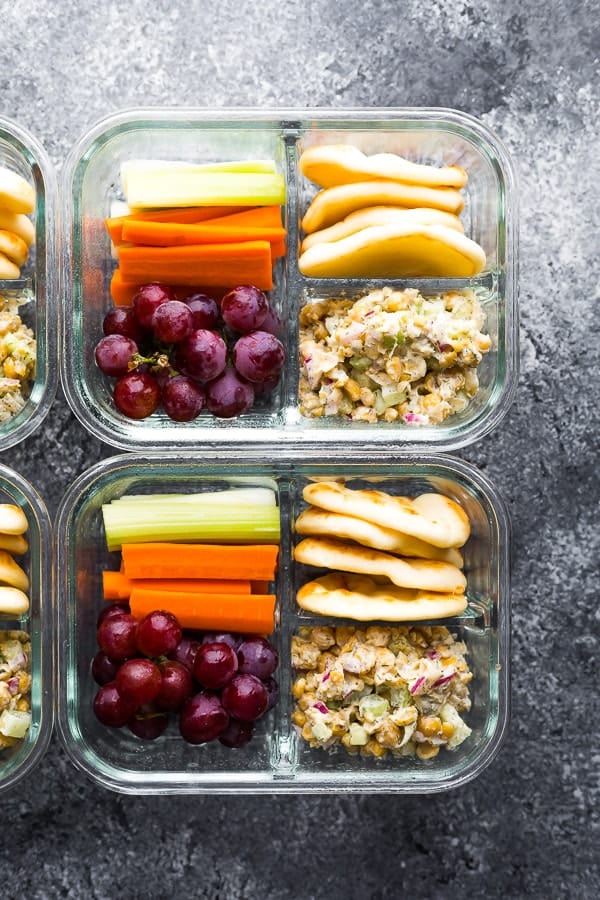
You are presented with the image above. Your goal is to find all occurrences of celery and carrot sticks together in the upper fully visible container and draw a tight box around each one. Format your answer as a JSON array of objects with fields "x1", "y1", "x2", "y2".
[{"x1": 106, "y1": 160, "x2": 286, "y2": 296}]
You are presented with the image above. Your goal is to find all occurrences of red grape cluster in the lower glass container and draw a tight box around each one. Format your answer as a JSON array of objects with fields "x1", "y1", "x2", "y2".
[{"x1": 92, "y1": 603, "x2": 279, "y2": 748}]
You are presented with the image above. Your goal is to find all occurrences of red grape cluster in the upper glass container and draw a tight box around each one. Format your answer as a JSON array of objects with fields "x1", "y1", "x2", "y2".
[{"x1": 95, "y1": 284, "x2": 285, "y2": 422}]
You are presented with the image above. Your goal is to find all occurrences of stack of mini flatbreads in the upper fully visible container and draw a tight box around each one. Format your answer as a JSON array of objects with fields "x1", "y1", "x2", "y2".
[{"x1": 298, "y1": 144, "x2": 486, "y2": 278}]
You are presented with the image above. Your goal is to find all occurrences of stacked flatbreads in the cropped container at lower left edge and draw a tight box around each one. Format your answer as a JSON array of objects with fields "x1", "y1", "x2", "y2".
[{"x1": 0, "y1": 503, "x2": 29, "y2": 617}]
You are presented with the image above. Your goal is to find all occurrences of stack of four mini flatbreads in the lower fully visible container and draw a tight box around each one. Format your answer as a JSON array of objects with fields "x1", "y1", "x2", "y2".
[{"x1": 294, "y1": 482, "x2": 470, "y2": 622}]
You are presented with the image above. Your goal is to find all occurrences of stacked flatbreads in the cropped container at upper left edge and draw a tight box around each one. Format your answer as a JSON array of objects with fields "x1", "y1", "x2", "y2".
[{"x1": 0, "y1": 166, "x2": 35, "y2": 281}]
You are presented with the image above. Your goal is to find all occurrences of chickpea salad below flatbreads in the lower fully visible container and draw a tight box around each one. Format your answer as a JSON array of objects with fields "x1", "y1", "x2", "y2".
[{"x1": 292, "y1": 625, "x2": 473, "y2": 760}]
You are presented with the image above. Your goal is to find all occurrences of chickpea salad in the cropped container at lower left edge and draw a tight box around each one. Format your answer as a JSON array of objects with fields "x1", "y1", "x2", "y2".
[{"x1": 0, "y1": 631, "x2": 31, "y2": 750}]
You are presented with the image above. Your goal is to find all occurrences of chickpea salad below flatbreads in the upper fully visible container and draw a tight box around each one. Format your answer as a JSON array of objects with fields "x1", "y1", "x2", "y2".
[{"x1": 299, "y1": 287, "x2": 491, "y2": 425}]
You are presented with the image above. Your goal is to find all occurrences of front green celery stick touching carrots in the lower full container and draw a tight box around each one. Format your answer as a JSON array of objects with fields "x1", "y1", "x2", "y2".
[{"x1": 102, "y1": 501, "x2": 280, "y2": 550}]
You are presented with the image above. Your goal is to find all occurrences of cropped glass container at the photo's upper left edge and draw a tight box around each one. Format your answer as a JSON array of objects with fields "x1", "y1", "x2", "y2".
[{"x1": 0, "y1": 116, "x2": 58, "y2": 450}]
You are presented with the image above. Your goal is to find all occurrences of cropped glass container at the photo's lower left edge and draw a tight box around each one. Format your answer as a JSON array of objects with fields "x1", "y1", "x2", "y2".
[{"x1": 0, "y1": 465, "x2": 54, "y2": 793}]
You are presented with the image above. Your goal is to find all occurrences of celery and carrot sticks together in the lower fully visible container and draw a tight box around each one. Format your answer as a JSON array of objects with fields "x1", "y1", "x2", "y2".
[{"x1": 102, "y1": 487, "x2": 279, "y2": 634}]
